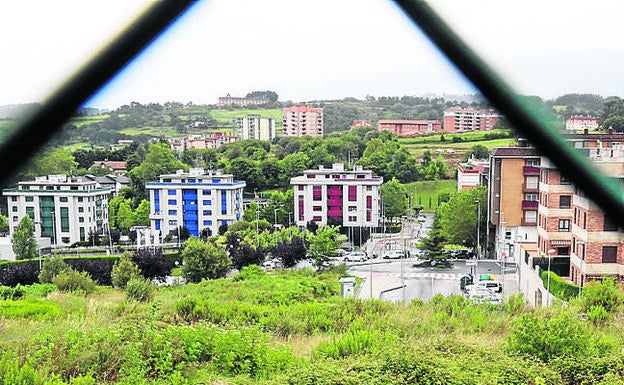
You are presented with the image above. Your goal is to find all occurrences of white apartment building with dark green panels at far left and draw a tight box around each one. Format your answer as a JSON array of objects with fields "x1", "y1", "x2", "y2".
[{"x1": 2, "y1": 175, "x2": 112, "y2": 246}]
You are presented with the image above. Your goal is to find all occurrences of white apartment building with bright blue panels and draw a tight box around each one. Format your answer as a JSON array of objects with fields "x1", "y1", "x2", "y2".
[{"x1": 145, "y1": 168, "x2": 246, "y2": 243}]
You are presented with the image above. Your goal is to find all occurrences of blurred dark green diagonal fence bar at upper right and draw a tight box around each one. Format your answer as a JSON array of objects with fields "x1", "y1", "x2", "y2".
[{"x1": 395, "y1": 0, "x2": 624, "y2": 226}]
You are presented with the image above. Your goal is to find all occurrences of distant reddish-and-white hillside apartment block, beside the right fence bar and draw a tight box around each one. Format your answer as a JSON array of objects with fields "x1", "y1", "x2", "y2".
[{"x1": 444, "y1": 107, "x2": 502, "y2": 133}]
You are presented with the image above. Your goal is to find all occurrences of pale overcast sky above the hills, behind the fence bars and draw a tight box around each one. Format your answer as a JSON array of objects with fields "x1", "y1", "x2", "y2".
[{"x1": 0, "y1": 0, "x2": 624, "y2": 108}]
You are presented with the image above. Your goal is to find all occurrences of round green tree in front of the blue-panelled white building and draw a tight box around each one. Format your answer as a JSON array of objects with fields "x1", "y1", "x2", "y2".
[{"x1": 182, "y1": 237, "x2": 232, "y2": 283}]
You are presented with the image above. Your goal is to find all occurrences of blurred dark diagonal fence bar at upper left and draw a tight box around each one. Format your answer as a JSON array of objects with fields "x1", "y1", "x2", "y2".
[{"x1": 0, "y1": 0, "x2": 193, "y2": 183}]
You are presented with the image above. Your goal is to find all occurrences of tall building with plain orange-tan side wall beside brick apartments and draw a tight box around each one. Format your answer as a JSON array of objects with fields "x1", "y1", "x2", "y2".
[{"x1": 486, "y1": 147, "x2": 541, "y2": 258}]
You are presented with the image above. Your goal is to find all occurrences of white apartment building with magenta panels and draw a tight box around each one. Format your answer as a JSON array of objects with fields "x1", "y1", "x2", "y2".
[{"x1": 290, "y1": 163, "x2": 383, "y2": 227}]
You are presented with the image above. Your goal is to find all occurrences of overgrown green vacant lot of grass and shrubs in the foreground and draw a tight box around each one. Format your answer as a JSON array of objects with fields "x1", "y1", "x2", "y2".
[{"x1": 0, "y1": 266, "x2": 624, "y2": 385}]
